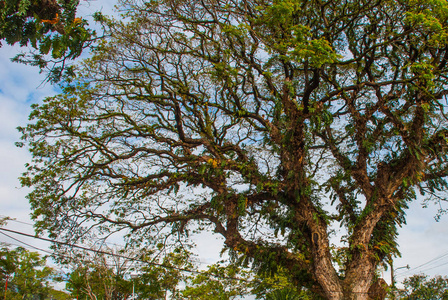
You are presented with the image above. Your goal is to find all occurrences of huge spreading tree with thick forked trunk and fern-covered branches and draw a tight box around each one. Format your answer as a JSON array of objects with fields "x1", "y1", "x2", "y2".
[{"x1": 21, "y1": 0, "x2": 448, "y2": 299}]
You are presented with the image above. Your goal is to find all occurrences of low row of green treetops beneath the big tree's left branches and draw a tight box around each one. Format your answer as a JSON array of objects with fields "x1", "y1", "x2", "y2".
[{"x1": 63, "y1": 248, "x2": 304, "y2": 300}]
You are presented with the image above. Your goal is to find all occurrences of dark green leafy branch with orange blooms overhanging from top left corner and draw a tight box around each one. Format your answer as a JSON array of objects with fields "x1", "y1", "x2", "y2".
[{"x1": 0, "y1": 0, "x2": 95, "y2": 82}]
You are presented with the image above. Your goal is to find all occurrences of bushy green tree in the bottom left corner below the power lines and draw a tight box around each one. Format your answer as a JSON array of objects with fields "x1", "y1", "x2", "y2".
[{"x1": 0, "y1": 246, "x2": 67, "y2": 300}]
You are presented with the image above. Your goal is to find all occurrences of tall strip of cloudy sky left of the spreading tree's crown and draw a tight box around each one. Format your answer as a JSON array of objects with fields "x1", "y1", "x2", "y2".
[{"x1": 0, "y1": 45, "x2": 55, "y2": 242}]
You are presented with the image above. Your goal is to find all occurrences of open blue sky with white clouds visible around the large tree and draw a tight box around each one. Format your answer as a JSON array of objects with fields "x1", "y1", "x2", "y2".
[{"x1": 0, "y1": 1, "x2": 448, "y2": 288}]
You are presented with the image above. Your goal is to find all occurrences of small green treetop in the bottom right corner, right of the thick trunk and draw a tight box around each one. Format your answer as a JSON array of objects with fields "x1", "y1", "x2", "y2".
[{"x1": 398, "y1": 274, "x2": 448, "y2": 300}]
